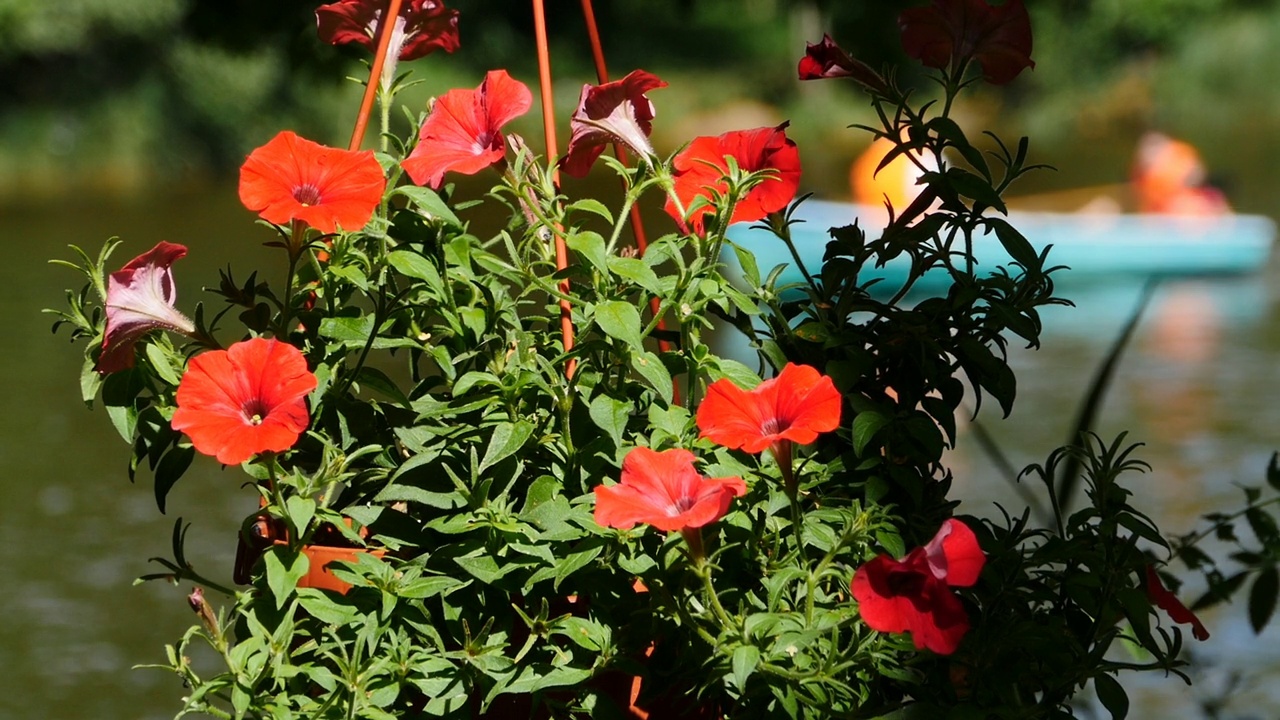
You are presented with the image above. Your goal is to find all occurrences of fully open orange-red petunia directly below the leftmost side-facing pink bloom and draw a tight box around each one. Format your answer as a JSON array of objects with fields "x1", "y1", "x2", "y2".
[{"x1": 170, "y1": 337, "x2": 316, "y2": 465}]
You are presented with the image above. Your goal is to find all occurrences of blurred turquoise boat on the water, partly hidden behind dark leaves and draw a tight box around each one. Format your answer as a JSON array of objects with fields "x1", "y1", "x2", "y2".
[{"x1": 726, "y1": 200, "x2": 1276, "y2": 290}]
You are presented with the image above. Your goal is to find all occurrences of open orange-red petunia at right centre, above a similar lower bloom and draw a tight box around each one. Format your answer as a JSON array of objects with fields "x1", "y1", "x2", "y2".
[{"x1": 698, "y1": 363, "x2": 842, "y2": 454}]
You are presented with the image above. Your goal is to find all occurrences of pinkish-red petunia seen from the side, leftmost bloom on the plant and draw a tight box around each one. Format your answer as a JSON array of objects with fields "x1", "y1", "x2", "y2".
[{"x1": 93, "y1": 242, "x2": 196, "y2": 373}]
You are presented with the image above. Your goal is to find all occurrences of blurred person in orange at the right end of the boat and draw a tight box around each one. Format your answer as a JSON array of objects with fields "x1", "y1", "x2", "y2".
[{"x1": 1133, "y1": 132, "x2": 1231, "y2": 215}]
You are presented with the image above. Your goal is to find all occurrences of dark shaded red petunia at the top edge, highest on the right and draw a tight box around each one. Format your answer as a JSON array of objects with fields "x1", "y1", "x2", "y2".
[{"x1": 897, "y1": 0, "x2": 1036, "y2": 85}]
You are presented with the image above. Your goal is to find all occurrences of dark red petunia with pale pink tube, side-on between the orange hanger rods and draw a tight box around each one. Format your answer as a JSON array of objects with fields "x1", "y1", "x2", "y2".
[{"x1": 561, "y1": 70, "x2": 667, "y2": 178}]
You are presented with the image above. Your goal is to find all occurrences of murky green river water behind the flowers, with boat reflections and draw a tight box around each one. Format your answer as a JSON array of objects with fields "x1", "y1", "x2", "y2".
[{"x1": 10, "y1": 183, "x2": 1280, "y2": 720}]
